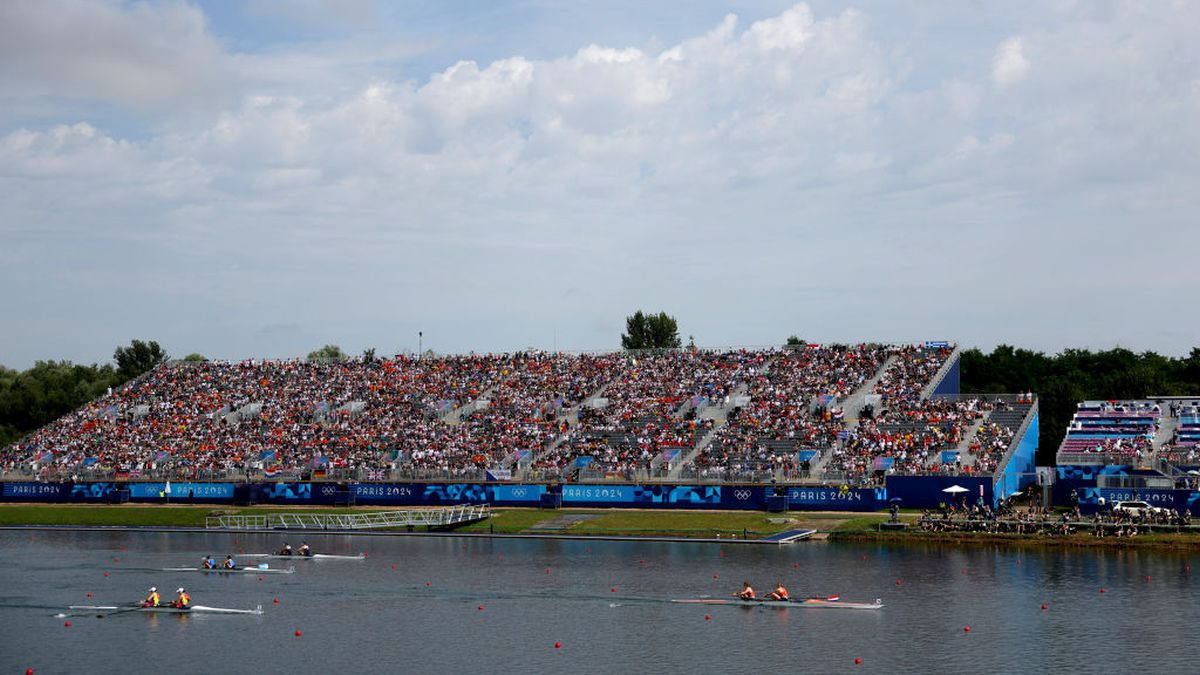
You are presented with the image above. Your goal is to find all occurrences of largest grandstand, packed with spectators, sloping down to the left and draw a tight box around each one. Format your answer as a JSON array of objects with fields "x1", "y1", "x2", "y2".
[{"x1": 0, "y1": 342, "x2": 1036, "y2": 485}]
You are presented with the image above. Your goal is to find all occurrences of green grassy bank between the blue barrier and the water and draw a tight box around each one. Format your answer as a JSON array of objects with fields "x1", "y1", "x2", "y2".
[{"x1": 7, "y1": 503, "x2": 1200, "y2": 552}]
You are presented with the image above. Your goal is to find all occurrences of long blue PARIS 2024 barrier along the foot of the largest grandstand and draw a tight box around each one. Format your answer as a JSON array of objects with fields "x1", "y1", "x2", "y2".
[{"x1": 0, "y1": 483, "x2": 887, "y2": 510}]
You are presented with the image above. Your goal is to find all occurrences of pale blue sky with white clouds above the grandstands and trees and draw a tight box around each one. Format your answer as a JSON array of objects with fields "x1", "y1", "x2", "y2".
[{"x1": 0, "y1": 0, "x2": 1200, "y2": 368}]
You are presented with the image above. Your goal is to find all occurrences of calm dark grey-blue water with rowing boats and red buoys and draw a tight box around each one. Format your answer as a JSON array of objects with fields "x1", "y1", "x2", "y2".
[{"x1": 0, "y1": 532, "x2": 1200, "y2": 674}]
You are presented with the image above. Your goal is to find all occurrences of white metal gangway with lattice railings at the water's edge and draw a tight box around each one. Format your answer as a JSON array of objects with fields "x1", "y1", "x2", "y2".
[{"x1": 204, "y1": 504, "x2": 492, "y2": 530}]
